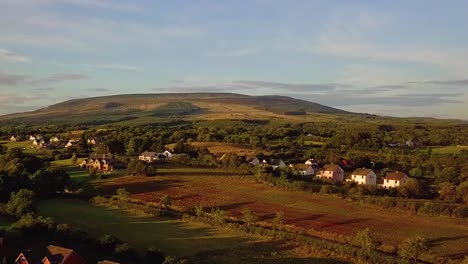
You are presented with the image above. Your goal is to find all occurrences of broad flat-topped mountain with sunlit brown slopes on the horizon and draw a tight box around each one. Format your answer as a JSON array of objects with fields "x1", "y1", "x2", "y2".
[{"x1": 0, "y1": 93, "x2": 352, "y2": 124}]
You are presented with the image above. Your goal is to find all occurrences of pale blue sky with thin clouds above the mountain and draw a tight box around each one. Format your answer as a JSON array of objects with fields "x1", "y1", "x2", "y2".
[{"x1": 0, "y1": 0, "x2": 468, "y2": 120}]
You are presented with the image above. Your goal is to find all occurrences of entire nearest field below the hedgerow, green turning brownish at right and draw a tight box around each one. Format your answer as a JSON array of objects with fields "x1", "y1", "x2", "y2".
[{"x1": 37, "y1": 199, "x2": 342, "y2": 263}]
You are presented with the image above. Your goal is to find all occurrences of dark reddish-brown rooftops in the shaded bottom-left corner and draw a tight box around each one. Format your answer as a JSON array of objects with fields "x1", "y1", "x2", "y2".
[{"x1": 15, "y1": 245, "x2": 119, "y2": 264}]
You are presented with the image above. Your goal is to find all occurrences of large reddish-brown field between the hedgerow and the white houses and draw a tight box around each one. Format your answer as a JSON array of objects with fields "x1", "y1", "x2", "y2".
[{"x1": 93, "y1": 168, "x2": 468, "y2": 257}]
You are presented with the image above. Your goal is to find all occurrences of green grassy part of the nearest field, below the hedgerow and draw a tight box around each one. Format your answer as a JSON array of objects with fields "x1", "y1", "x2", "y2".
[{"x1": 37, "y1": 199, "x2": 253, "y2": 256}]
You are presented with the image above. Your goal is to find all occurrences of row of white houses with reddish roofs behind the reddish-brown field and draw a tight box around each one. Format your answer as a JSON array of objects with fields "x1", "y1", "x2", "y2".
[{"x1": 245, "y1": 156, "x2": 409, "y2": 188}]
